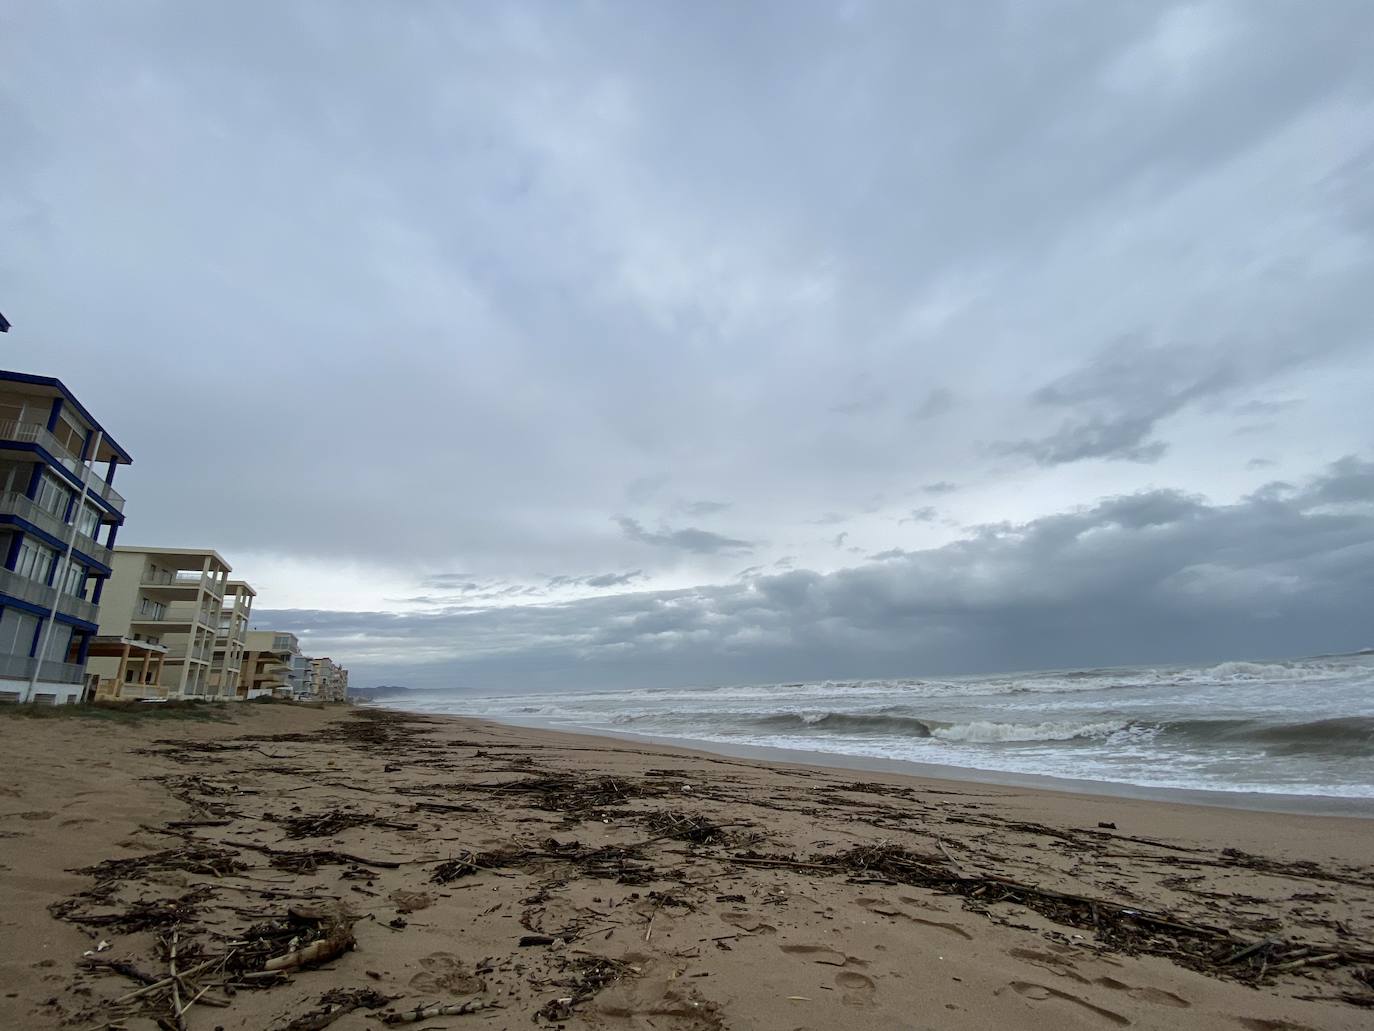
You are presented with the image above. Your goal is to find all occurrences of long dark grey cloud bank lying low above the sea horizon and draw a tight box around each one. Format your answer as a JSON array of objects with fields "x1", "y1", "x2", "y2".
[{"x1": 258, "y1": 456, "x2": 1374, "y2": 686}]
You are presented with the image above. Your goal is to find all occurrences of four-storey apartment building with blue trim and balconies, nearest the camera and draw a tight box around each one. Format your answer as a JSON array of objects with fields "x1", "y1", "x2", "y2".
[{"x1": 0, "y1": 371, "x2": 133, "y2": 704}]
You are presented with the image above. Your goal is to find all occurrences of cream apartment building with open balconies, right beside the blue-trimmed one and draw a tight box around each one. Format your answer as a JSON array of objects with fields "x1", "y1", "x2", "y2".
[{"x1": 91, "y1": 547, "x2": 229, "y2": 698}]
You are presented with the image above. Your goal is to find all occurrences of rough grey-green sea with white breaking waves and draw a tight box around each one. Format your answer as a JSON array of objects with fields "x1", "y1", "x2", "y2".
[{"x1": 386, "y1": 650, "x2": 1374, "y2": 800}]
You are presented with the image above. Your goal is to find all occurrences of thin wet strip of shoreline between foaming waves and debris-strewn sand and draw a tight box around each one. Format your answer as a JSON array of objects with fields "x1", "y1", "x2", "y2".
[{"x1": 373, "y1": 701, "x2": 1374, "y2": 819}]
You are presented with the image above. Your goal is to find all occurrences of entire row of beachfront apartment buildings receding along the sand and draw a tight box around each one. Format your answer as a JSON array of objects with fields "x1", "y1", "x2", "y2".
[{"x1": 0, "y1": 370, "x2": 348, "y2": 704}]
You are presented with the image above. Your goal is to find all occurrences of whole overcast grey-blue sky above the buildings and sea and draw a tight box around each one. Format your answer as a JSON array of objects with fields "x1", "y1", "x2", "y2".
[{"x1": 0, "y1": 0, "x2": 1374, "y2": 690}]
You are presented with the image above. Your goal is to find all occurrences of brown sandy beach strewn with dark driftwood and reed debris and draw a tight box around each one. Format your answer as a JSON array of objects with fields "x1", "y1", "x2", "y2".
[{"x1": 0, "y1": 705, "x2": 1374, "y2": 1031}]
